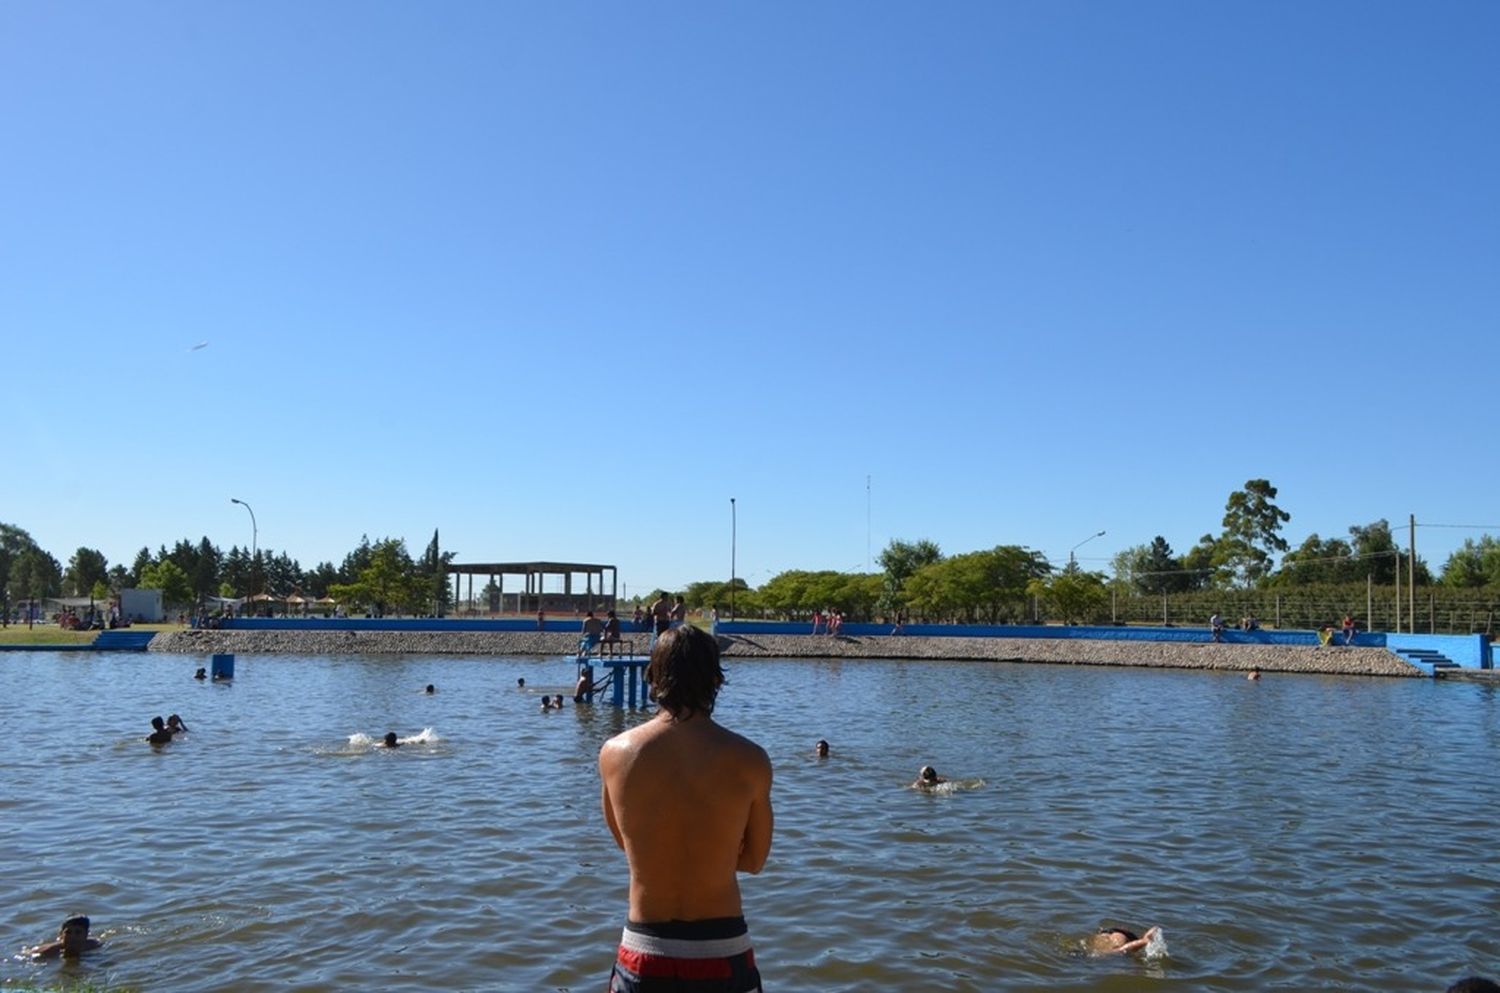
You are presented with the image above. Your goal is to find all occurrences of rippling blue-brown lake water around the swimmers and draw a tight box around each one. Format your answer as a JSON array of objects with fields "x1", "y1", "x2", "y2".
[{"x1": 0, "y1": 653, "x2": 1500, "y2": 993}]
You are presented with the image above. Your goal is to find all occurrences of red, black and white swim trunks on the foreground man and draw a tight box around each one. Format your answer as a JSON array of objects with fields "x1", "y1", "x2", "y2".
[{"x1": 609, "y1": 917, "x2": 761, "y2": 993}]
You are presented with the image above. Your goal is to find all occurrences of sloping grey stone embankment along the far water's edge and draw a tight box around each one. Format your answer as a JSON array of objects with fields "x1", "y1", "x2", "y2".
[{"x1": 150, "y1": 629, "x2": 1424, "y2": 677}]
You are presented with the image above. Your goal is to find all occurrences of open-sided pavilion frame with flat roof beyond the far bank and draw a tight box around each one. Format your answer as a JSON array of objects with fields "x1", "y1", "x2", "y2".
[{"x1": 447, "y1": 563, "x2": 620, "y2": 614}]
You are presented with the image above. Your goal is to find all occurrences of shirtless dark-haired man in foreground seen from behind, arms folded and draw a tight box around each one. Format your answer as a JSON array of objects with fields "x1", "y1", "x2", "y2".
[{"x1": 599, "y1": 626, "x2": 773, "y2": 993}]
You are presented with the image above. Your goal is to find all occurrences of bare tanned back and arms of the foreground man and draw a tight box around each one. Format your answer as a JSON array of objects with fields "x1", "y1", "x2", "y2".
[{"x1": 599, "y1": 711, "x2": 773, "y2": 921}]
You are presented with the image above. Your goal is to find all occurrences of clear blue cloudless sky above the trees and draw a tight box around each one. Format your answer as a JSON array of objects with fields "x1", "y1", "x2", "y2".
[{"x1": 0, "y1": 0, "x2": 1500, "y2": 593}]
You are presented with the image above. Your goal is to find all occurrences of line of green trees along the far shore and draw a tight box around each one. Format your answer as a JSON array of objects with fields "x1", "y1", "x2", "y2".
[{"x1": 0, "y1": 479, "x2": 1500, "y2": 623}]
